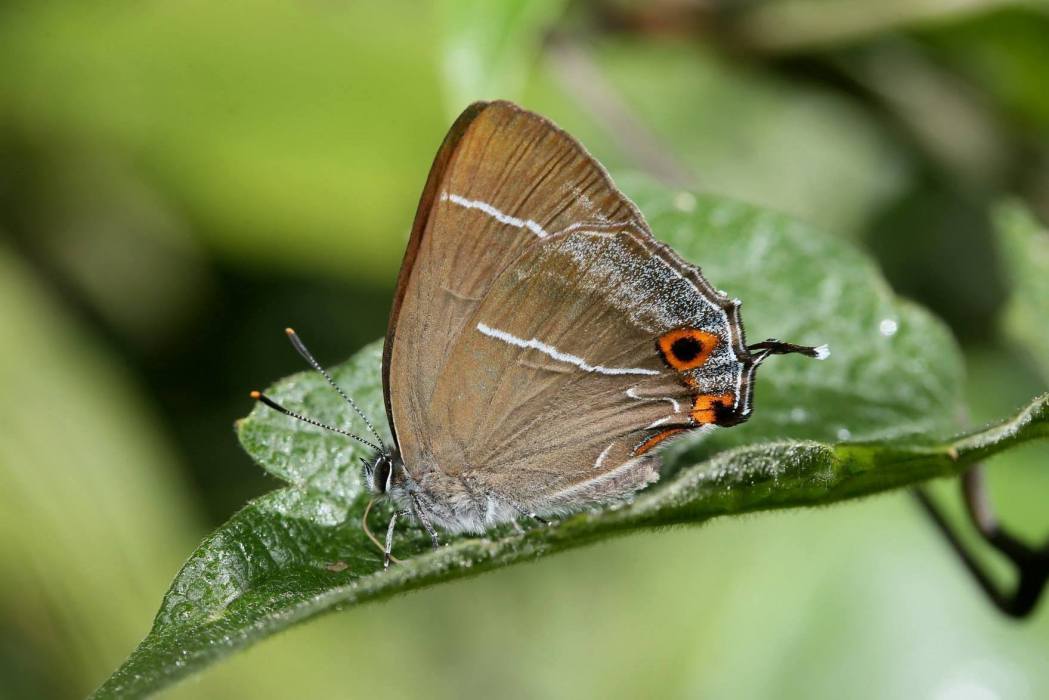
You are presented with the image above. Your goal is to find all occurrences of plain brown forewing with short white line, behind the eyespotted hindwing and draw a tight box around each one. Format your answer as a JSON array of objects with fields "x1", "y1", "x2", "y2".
[{"x1": 383, "y1": 102, "x2": 644, "y2": 465}]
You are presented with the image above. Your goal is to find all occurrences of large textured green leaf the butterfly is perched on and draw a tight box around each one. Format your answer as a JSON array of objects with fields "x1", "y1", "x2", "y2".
[{"x1": 97, "y1": 188, "x2": 1049, "y2": 697}]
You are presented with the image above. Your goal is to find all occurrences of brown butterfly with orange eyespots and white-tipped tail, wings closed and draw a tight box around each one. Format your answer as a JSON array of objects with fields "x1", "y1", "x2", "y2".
[{"x1": 253, "y1": 101, "x2": 827, "y2": 566}]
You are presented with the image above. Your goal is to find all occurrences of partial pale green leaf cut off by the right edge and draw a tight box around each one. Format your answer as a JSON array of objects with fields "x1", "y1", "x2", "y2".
[{"x1": 994, "y1": 201, "x2": 1049, "y2": 381}]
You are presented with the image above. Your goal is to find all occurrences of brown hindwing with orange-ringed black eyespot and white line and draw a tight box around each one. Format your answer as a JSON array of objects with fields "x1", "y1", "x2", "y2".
[{"x1": 421, "y1": 226, "x2": 747, "y2": 512}]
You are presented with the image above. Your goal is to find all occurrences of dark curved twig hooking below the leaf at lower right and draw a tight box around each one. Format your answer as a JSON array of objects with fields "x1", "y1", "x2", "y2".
[{"x1": 915, "y1": 465, "x2": 1049, "y2": 618}]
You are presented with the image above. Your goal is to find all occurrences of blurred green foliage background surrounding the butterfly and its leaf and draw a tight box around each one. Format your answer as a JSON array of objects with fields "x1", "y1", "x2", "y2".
[{"x1": 0, "y1": 0, "x2": 1049, "y2": 699}]
